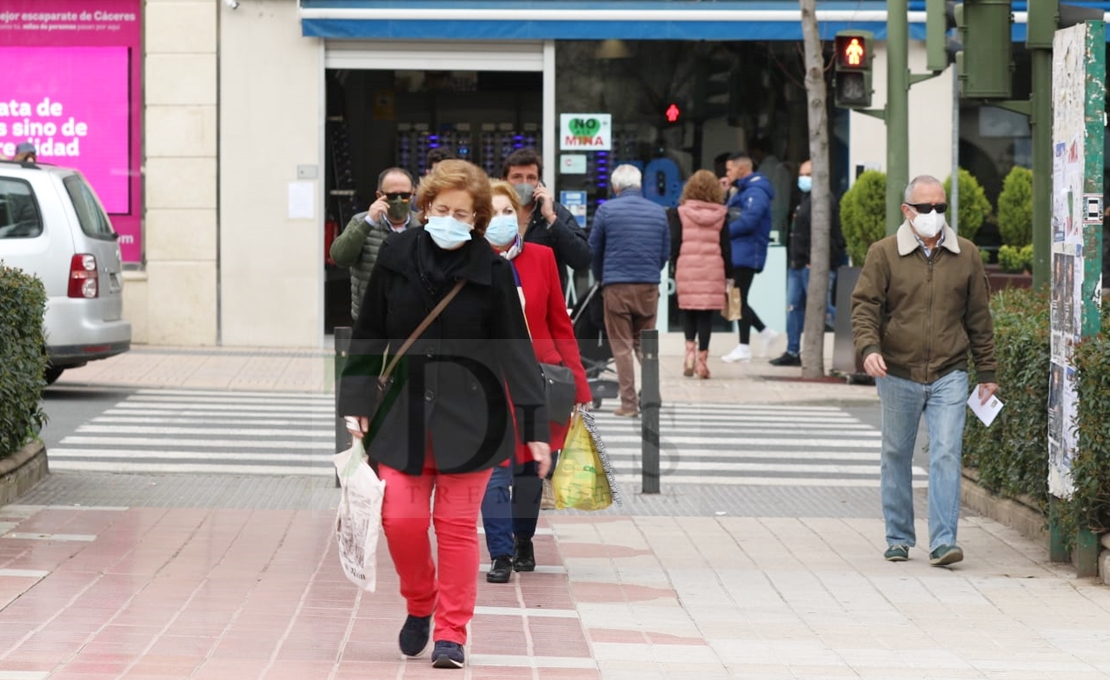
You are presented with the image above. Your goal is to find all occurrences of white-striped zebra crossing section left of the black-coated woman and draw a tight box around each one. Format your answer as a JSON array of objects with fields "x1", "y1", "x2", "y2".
[{"x1": 47, "y1": 389, "x2": 335, "y2": 476}]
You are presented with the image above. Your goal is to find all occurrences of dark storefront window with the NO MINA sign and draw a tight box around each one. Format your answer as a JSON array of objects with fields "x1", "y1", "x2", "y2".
[{"x1": 555, "y1": 40, "x2": 847, "y2": 331}]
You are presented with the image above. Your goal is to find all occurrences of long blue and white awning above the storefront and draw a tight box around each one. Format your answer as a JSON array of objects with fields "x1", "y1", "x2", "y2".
[{"x1": 300, "y1": 0, "x2": 1110, "y2": 41}]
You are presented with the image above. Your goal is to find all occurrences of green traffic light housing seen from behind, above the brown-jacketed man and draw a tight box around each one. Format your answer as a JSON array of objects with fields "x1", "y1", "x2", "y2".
[{"x1": 956, "y1": 0, "x2": 1013, "y2": 99}]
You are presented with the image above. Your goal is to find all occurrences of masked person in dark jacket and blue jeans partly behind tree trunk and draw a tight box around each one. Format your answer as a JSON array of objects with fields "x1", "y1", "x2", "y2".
[{"x1": 770, "y1": 161, "x2": 845, "y2": 366}]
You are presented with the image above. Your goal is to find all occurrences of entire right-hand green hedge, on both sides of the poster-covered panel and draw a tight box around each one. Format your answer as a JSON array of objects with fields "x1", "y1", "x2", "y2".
[{"x1": 963, "y1": 288, "x2": 1110, "y2": 547}]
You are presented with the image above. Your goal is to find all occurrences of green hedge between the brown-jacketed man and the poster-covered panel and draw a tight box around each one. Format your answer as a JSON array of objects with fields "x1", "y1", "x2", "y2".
[{"x1": 961, "y1": 286, "x2": 1050, "y2": 507}]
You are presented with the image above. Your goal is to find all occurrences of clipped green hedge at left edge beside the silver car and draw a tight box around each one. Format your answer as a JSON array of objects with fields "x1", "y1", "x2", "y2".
[{"x1": 0, "y1": 262, "x2": 47, "y2": 458}]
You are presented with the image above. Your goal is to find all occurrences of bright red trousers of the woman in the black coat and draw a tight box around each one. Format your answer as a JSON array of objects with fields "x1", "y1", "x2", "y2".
[{"x1": 379, "y1": 465, "x2": 493, "y2": 645}]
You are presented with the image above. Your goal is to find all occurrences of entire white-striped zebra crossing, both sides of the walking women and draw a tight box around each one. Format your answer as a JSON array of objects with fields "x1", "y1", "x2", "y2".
[{"x1": 48, "y1": 389, "x2": 926, "y2": 487}]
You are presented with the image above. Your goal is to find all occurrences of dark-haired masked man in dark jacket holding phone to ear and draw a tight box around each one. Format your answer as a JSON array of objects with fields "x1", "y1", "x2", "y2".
[{"x1": 501, "y1": 148, "x2": 589, "y2": 294}]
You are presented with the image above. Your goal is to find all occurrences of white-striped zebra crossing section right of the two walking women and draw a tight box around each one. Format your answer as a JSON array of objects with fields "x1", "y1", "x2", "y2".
[{"x1": 595, "y1": 404, "x2": 927, "y2": 487}]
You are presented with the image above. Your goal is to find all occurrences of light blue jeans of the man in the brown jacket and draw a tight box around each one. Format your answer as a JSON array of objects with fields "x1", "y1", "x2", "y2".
[{"x1": 875, "y1": 371, "x2": 968, "y2": 551}]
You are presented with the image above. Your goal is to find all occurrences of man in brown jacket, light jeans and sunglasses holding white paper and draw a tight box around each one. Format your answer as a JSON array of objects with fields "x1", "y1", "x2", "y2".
[{"x1": 851, "y1": 175, "x2": 998, "y2": 566}]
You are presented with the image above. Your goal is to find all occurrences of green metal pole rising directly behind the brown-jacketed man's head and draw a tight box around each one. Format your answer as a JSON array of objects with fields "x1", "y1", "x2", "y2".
[{"x1": 886, "y1": 0, "x2": 909, "y2": 236}]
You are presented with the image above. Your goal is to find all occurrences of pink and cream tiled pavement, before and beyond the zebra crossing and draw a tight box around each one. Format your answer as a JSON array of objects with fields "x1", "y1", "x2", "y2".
[{"x1": 0, "y1": 339, "x2": 1110, "y2": 680}]
